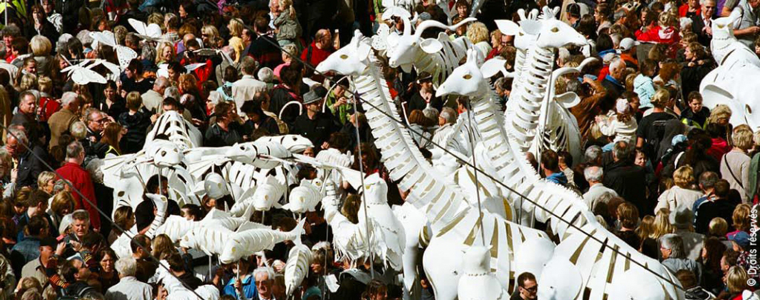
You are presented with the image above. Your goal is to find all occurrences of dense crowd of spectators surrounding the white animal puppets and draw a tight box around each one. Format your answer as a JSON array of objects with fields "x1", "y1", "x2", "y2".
[{"x1": 0, "y1": 0, "x2": 760, "y2": 300}]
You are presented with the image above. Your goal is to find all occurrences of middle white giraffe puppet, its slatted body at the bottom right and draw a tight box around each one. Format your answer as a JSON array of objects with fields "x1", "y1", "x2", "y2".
[{"x1": 438, "y1": 45, "x2": 684, "y2": 299}]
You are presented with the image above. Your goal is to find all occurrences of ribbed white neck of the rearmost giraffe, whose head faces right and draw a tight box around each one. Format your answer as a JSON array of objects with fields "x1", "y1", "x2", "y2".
[{"x1": 506, "y1": 47, "x2": 554, "y2": 152}]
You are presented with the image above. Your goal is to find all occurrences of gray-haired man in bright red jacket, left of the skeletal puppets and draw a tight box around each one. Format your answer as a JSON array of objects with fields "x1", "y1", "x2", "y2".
[{"x1": 56, "y1": 141, "x2": 100, "y2": 231}]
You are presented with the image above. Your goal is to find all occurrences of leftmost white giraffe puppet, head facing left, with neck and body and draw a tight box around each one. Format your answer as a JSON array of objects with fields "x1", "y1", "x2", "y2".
[{"x1": 317, "y1": 32, "x2": 547, "y2": 299}]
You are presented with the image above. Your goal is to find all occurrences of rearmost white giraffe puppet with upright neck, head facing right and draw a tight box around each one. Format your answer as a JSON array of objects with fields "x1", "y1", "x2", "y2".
[{"x1": 496, "y1": 7, "x2": 593, "y2": 161}]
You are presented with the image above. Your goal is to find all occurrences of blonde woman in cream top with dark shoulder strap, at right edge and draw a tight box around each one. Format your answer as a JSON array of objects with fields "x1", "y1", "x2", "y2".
[{"x1": 720, "y1": 125, "x2": 754, "y2": 203}]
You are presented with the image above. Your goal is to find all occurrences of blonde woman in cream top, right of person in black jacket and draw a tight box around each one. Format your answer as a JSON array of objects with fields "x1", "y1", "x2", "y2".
[{"x1": 655, "y1": 166, "x2": 702, "y2": 212}]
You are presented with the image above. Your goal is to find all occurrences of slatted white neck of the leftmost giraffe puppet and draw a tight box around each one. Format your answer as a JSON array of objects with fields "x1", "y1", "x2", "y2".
[{"x1": 355, "y1": 56, "x2": 466, "y2": 231}]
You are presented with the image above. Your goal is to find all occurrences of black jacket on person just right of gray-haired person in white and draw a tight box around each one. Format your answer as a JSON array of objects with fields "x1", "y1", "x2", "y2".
[{"x1": 602, "y1": 160, "x2": 652, "y2": 211}]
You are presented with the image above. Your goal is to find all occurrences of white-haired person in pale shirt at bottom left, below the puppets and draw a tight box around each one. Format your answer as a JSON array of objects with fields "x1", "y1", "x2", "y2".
[{"x1": 106, "y1": 257, "x2": 153, "y2": 300}]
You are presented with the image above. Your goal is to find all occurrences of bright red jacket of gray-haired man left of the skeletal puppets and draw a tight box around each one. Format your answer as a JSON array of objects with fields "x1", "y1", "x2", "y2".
[{"x1": 56, "y1": 162, "x2": 100, "y2": 230}]
